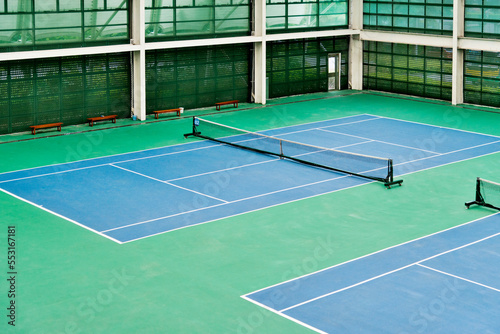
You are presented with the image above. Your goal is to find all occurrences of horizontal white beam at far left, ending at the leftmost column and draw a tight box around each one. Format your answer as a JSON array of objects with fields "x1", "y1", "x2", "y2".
[{"x1": 0, "y1": 44, "x2": 141, "y2": 61}]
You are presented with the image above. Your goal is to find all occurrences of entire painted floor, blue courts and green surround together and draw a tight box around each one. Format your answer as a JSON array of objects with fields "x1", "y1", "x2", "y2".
[{"x1": 0, "y1": 92, "x2": 500, "y2": 333}]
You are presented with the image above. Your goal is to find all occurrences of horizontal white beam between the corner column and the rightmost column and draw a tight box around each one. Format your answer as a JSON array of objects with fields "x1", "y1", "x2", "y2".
[{"x1": 361, "y1": 30, "x2": 453, "y2": 48}]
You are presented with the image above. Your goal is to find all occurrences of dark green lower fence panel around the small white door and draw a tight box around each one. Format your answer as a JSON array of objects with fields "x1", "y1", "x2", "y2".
[{"x1": 267, "y1": 37, "x2": 349, "y2": 98}]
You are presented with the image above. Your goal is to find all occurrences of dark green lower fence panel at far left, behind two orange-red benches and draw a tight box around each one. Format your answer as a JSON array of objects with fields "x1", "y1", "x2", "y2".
[{"x1": 0, "y1": 54, "x2": 131, "y2": 134}]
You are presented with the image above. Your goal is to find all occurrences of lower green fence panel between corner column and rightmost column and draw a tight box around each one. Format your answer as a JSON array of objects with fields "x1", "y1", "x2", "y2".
[{"x1": 363, "y1": 41, "x2": 452, "y2": 100}]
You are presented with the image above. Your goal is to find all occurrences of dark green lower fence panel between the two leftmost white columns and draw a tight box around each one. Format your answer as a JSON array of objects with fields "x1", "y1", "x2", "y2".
[{"x1": 146, "y1": 44, "x2": 251, "y2": 114}]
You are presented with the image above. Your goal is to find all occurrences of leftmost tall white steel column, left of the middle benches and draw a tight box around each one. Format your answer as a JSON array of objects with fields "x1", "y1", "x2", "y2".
[{"x1": 131, "y1": 0, "x2": 146, "y2": 121}]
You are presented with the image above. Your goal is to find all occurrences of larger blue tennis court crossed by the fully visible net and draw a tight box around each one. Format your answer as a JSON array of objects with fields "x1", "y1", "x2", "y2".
[{"x1": 0, "y1": 114, "x2": 500, "y2": 243}]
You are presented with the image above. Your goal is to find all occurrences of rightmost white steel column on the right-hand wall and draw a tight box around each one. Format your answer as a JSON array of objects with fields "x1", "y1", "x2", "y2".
[{"x1": 451, "y1": 0, "x2": 465, "y2": 104}]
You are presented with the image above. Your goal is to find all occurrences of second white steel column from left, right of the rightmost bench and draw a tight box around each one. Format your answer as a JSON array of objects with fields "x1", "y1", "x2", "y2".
[{"x1": 252, "y1": 0, "x2": 267, "y2": 104}]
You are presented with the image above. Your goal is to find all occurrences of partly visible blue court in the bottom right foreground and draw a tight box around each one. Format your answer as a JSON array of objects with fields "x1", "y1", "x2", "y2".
[{"x1": 243, "y1": 213, "x2": 500, "y2": 334}]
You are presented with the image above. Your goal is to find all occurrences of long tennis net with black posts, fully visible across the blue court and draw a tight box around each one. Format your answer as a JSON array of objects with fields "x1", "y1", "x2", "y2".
[{"x1": 184, "y1": 117, "x2": 403, "y2": 188}]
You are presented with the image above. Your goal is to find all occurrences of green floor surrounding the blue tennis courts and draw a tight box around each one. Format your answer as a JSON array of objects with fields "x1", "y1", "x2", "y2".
[{"x1": 0, "y1": 91, "x2": 500, "y2": 334}]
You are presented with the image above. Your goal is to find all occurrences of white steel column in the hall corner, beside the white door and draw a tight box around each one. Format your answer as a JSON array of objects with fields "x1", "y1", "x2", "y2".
[{"x1": 349, "y1": 0, "x2": 363, "y2": 89}]
